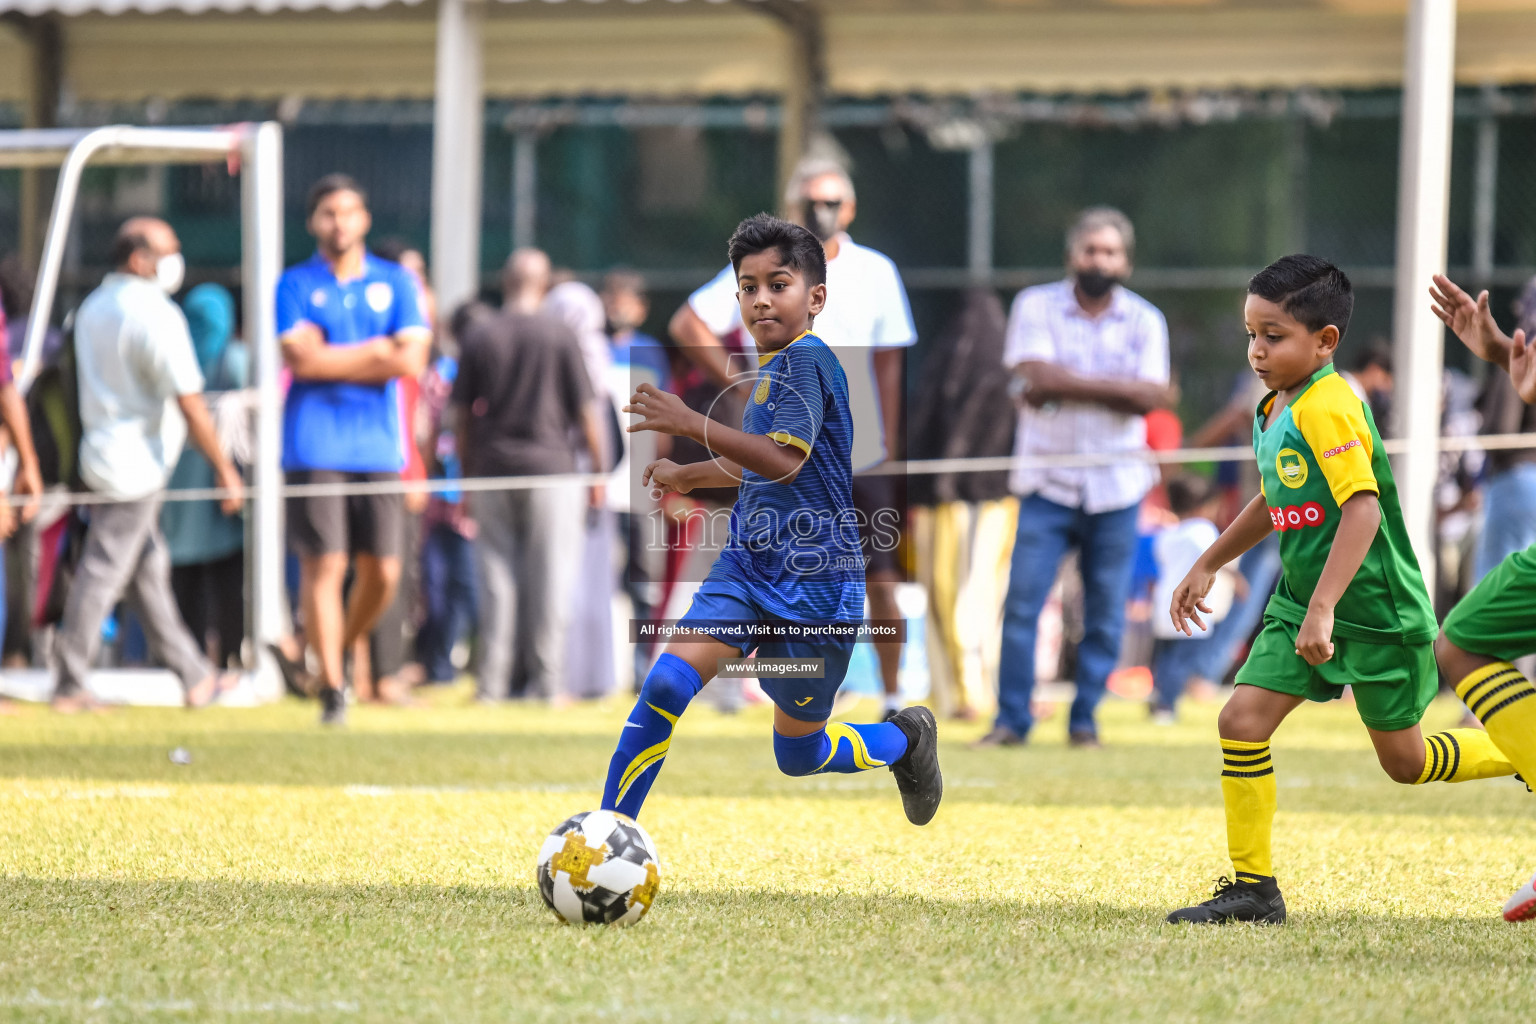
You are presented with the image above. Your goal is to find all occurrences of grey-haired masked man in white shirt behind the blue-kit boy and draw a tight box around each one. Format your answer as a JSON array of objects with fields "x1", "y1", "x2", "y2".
[{"x1": 670, "y1": 158, "x2": 917, "y2": 718}]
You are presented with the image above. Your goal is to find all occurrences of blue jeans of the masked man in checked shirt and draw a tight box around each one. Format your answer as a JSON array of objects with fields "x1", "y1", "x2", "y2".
[{"x1": 997, "y1": 494, "x2": 1137, "y2": 735}]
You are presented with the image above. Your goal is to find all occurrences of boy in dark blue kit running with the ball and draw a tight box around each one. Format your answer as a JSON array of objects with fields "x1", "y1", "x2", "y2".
[{"x1": 602, "y1": 213, "x2": 943, "y2": 824}]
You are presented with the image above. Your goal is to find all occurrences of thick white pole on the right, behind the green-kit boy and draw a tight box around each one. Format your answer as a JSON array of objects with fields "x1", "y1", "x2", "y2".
[{"x1": 1393, "y1": 0, "x2": 1456, "y2": 593}]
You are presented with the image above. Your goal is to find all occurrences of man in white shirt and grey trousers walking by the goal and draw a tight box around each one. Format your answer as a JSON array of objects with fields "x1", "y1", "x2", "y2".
[{"x1": 52, "y1": 216, "x2": 243, "y2": 711}]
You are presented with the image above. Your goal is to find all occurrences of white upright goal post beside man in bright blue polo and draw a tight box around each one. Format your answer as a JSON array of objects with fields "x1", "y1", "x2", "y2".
[{"x1": 240, "y1": 121, "x2": 287, "y2": 695}]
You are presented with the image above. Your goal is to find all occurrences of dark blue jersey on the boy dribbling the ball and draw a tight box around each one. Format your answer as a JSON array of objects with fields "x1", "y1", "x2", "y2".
[{"x1": 708, "y1": 332, "x2": 865, "y2": 622}]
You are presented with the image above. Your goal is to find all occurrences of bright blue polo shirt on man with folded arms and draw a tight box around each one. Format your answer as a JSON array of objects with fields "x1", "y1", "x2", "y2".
[{"x1": 276, "y1": 253, "x2": 427, "y2": 473}]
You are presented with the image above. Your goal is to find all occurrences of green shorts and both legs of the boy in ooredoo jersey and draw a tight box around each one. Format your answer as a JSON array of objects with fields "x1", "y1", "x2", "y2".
[{"x1": 1169, "y1": 617, "x2": 1514, "y2": 924}]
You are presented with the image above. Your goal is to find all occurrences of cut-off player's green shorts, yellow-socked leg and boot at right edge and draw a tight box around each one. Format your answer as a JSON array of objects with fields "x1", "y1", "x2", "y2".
[{"x1": 1435, "y1": 548, "x2": 1536, "y2": 921}]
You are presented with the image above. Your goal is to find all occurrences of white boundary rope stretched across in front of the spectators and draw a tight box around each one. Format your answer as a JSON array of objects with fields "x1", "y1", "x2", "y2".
[{"x1": 6, "y1": 434, "x2": 1536, "y2": 508}]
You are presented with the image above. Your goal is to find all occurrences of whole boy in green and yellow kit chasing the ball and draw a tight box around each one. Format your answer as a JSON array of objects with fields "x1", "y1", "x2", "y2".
[{"x1": 1167, "y1": 255, "x2": 1514, "y2": 924}]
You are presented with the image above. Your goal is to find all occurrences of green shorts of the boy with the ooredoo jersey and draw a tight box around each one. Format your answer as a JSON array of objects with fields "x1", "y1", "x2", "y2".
[{"x1": 1236, "y1": 616, "x2": 1439, "y2": 732}]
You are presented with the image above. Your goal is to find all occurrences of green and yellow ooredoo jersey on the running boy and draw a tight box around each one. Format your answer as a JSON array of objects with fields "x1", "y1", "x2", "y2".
[{"x1": 1253, "y1": 364, "x2": 1436, "y2": 645}]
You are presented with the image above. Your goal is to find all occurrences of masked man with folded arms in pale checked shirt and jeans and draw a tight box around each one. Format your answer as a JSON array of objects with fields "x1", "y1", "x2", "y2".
[{"x1": 980, "y1": 207, "x2": 1177, "y2": 746}]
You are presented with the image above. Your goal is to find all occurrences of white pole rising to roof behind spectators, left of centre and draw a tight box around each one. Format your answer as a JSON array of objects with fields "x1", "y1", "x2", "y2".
[{"x1": 432, "y1": 0, "x2": 485, "y2": 310}]
